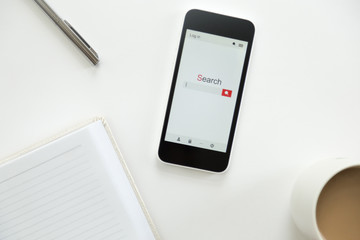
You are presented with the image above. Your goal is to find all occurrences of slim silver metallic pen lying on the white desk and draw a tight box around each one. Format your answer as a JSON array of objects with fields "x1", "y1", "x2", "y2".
[{"x1": 34, "y1": 0, "x2": 99, "y2": 65}]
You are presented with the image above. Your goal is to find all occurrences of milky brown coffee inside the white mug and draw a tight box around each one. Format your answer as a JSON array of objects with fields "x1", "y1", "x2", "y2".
[{"x1": 316, "y1": 167, "x2": 360, "y2": 240}]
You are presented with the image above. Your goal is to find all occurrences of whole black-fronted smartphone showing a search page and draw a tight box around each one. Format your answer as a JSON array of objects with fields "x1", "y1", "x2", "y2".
[{"x1": 158, "y1": 10, "x2": 255, "y2": 172}]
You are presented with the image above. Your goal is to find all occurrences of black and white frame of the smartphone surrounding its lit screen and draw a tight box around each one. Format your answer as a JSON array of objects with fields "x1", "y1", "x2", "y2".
[{"x1": 158, "y1": 9, "x2": 255, "y2": 172}]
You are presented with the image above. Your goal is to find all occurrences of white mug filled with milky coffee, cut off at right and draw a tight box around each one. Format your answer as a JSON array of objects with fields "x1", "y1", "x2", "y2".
[{"x1": 291, "y1": 158, "x2": 360, "y2": 240}]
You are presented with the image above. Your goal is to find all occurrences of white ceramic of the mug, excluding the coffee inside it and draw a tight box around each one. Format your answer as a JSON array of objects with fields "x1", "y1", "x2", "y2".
[{"x1": 291, "y1": 158, "x2": 360, "y2": 240}]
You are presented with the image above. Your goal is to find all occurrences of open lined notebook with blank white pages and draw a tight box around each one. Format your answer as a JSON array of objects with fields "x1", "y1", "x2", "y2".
[{"x1": 0, "y1": 118, "x2": 159, "y2": 240}]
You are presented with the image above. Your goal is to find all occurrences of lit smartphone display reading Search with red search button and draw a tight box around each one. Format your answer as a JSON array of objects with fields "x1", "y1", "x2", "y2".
[{"x1": 165, "y1": 29, "x2": 248, "y2": 152}]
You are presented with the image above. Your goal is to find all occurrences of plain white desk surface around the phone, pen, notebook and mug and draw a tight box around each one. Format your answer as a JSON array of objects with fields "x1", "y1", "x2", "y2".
[{"x1": 0, "y1": 0, "x2": 360, "y2": 240}]
